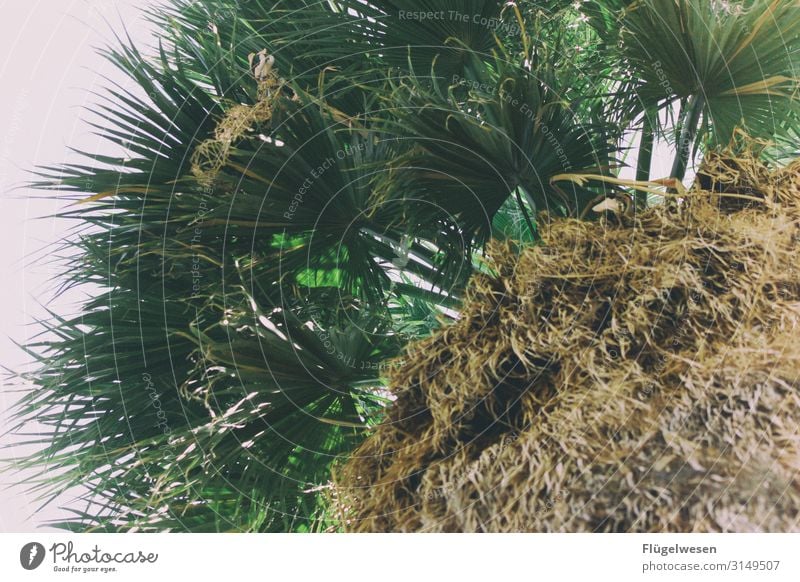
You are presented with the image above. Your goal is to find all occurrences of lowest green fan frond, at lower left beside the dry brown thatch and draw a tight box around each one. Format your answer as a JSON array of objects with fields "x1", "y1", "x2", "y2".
[{"x1": 12, "y1": 272, "x2": 402, "y2": 531}]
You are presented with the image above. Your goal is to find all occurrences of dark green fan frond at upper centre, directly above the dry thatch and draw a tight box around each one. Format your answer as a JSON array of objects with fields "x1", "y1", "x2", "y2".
[{"x1": 382, "y1": 53, "x2": 614, "y2": 235}]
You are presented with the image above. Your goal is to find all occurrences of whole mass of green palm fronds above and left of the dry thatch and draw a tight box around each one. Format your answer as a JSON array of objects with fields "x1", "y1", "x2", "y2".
[{"x1": 9, "y1": 0, "x2": 800, "y2": 531}]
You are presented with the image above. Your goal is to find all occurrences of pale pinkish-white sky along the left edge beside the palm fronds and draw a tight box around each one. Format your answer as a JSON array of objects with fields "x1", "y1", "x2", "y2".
[{"x1": 0, "y1": 0, "x2": 152, "y2": 532}]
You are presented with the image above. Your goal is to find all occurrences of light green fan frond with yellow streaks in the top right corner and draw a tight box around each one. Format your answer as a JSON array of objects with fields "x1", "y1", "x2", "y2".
[{"x1": 622, "y1": 0, "x2": 800, "y2": 145}]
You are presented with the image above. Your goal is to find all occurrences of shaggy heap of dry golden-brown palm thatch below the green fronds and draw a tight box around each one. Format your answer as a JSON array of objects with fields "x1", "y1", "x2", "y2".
[{"x1": 335, "y1": 147, "x2": 800, "y2": 532}]
